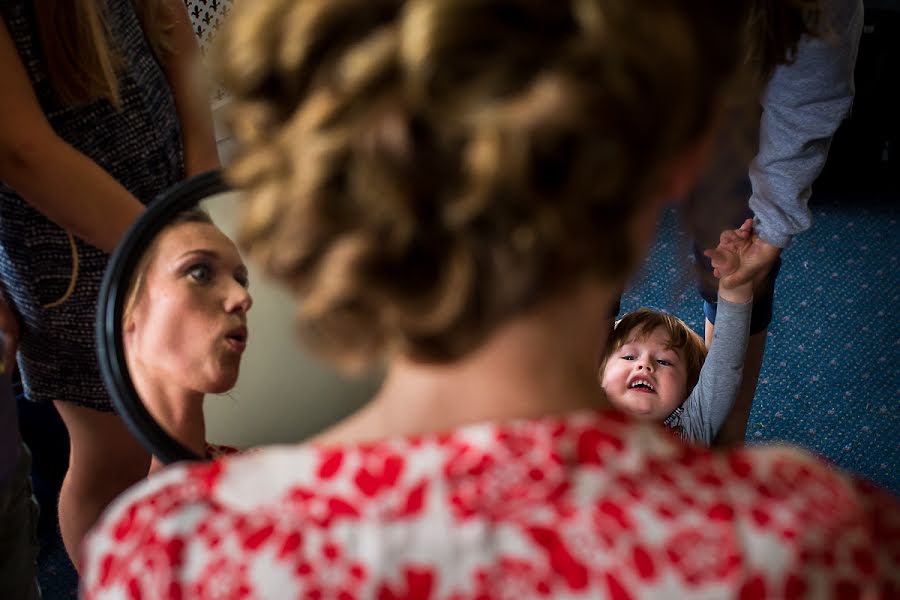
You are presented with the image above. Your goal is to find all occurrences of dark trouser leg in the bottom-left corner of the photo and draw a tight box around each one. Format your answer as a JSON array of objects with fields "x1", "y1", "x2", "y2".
[{"x1": 0, "y1": 444, "x2": 41, "y2": 600}]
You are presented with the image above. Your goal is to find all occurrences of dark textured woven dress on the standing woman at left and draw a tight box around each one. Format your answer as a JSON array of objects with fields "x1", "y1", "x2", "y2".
[{"x1": 0, "y1": 0, "x2": 184, "y2": 411}]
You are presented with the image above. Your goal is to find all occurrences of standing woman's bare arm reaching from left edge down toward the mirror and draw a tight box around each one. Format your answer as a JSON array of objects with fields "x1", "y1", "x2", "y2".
[{"x1": 0, "y1": 21, "x2": 144, "y2": 252}]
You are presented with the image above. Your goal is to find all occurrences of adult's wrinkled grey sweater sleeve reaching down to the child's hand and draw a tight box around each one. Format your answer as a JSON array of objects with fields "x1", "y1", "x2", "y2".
[{"x1": 744, "y1": 0, "x2": 863, "y2": 248}]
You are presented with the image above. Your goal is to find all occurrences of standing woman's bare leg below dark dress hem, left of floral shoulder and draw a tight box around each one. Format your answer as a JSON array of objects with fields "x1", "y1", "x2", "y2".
[{"x1": 55, "y1": 401, "x2": 150, "y2": 569}]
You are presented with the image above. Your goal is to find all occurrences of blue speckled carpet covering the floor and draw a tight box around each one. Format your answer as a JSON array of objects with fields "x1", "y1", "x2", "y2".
[{"x1": 40, "y1": 191, "x2": 900, "y2": 600}]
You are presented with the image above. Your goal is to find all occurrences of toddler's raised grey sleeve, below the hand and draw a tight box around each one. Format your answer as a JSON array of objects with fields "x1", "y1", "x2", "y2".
[{"x1": 680, "y1": 297, "x2": 753, "y2": 446}]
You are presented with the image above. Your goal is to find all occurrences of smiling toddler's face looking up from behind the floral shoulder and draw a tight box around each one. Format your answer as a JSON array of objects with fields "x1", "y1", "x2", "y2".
[{"x1": 601, "y1": 327, "x2": 688, "y2": 421}]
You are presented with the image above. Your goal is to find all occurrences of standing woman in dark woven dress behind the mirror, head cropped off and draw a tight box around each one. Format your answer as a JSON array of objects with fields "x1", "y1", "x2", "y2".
[{"x1": 0, "y1": 0, "x2": 218, "y2": 565}]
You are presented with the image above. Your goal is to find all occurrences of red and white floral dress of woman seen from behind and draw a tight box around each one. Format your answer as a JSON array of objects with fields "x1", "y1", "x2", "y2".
[{"x1": 81, "y1": 411, "x2": 900, "y2": 600}]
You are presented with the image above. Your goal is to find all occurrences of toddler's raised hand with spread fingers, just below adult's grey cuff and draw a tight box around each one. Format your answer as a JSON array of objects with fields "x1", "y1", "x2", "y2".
[{"x1": 703, "y1": 219, "x2": 781, "y2": 302}]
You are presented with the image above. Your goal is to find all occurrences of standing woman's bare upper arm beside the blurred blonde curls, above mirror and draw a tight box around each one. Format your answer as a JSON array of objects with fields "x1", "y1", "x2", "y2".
[{"x1": 163, "y1": 0, "x2": 219, "y2": 177}]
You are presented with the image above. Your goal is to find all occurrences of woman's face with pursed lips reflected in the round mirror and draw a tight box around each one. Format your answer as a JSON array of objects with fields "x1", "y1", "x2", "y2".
[{"x1": 124, "y1": 222, "x2": 252, "y2": 394}]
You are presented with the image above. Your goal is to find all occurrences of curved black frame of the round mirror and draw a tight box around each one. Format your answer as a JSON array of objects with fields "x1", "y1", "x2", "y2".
[{"x1": 96, "y1": 170, "x2": 230, "y2": 464}]
